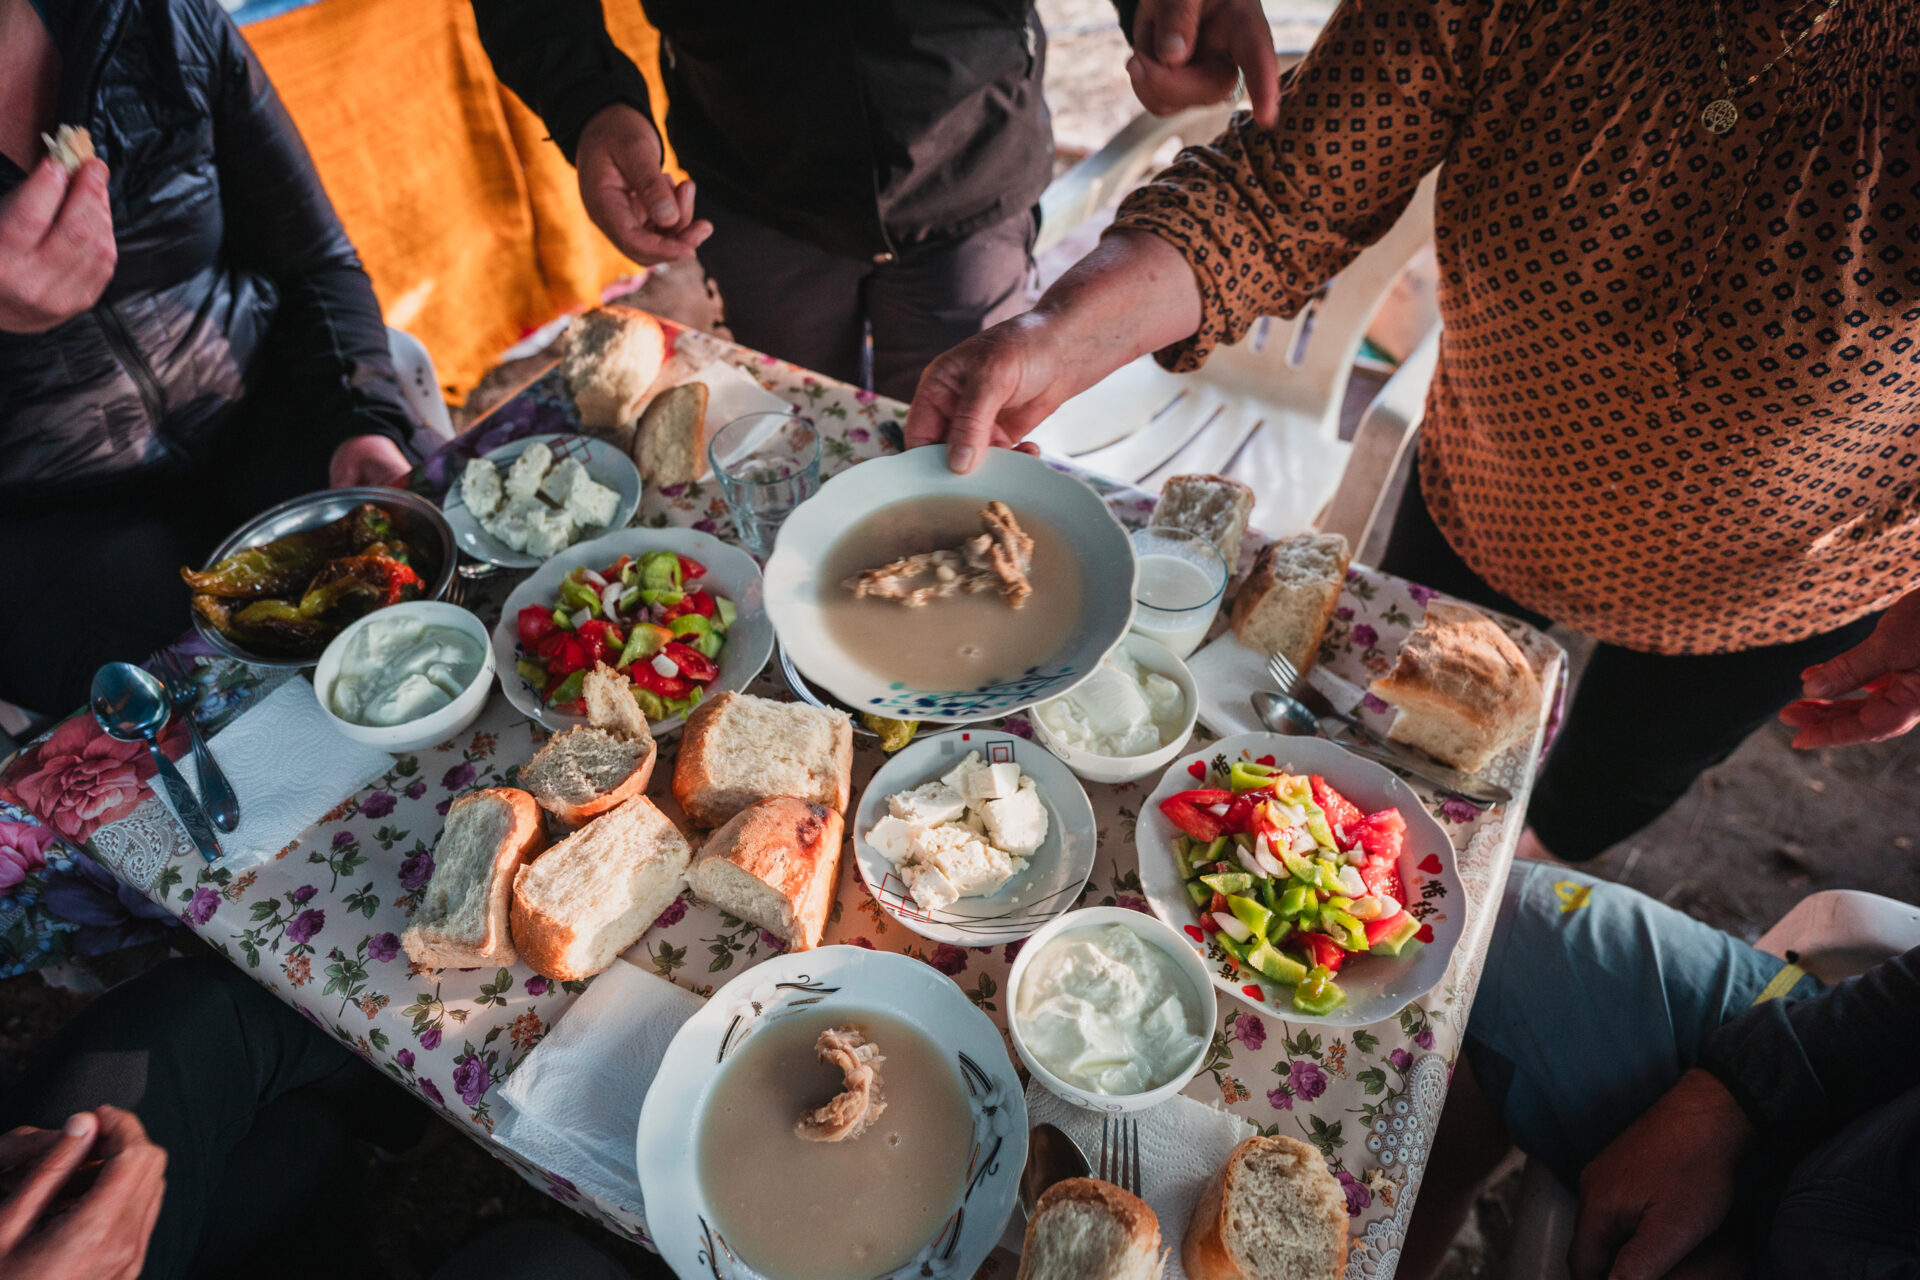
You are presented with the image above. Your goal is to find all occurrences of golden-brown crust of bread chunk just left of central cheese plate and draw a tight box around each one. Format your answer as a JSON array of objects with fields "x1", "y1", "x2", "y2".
[{"x1": 687, "y1": 796, "x2": 847, "y2": 952}]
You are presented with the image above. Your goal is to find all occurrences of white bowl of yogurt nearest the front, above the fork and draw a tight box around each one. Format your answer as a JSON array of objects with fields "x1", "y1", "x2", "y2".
[{"x1": 1006, "y1": 906, "x2": 1219, "y2": 1111}]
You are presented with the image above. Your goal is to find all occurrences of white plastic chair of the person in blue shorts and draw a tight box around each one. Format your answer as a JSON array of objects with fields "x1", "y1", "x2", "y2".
[{"x1": 1503, "y1": 889, "x2": 1920, "y2": 1280}]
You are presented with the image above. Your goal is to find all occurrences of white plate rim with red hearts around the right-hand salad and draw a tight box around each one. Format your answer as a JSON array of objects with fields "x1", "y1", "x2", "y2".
[{"x1": 1135, "y1": 733, "x2": 1467, "y2": 1027}]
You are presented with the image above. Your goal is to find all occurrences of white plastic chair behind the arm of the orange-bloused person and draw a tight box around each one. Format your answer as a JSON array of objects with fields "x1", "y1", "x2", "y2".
[{"x1": 1031, "y1": 94, "x2": 1434, "y2": 545}]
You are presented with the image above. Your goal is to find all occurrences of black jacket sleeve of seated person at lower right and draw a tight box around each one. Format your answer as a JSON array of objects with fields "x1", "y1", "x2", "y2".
[{"x1": 1699, "y1": 948, "x2": 1920, "y2": 1151}]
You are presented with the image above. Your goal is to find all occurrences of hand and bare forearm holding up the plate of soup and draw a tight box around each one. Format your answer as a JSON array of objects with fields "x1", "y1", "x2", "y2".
[{"x1": 904, "y1": 230, "x2": 1200, "y2": 472}]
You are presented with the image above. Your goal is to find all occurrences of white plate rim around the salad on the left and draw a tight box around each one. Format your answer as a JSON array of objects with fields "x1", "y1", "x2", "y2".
[{"x1": 493, "y1": 530, "x2": 774, "y2": 735}]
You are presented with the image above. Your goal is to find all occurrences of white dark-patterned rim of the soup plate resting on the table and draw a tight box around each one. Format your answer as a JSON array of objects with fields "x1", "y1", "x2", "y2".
[{"x1": 634, "y1": 946, "x2": 1027, "y2": 1280}]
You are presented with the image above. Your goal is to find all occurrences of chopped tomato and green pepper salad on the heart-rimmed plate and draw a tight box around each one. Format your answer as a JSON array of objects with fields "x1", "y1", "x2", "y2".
[{"x1": 1160, "y1": 760, "x2": 1421, "y2": 1015}]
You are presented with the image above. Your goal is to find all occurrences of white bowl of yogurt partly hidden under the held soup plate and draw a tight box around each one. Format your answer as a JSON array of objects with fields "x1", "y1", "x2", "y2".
[{"x1": 1029, "y1": 633, "x2": 1200, "y2": 785}]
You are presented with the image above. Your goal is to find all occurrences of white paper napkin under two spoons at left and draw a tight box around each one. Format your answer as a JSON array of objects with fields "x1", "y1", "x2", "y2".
[{"x1": 154, "y1": 676, "x2": 394, "y2": 871}]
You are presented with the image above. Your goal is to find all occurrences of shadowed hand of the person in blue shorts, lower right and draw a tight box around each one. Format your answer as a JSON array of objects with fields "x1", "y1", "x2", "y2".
[{"x1": 1567, "y1": 1069, "x2": 1753, "y2": 1280}]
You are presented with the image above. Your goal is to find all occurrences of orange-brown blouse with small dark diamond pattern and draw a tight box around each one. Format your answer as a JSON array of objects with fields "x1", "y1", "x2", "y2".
[{"x1": 1116, "y1": 0, "x2": 1920, "y2": 652}]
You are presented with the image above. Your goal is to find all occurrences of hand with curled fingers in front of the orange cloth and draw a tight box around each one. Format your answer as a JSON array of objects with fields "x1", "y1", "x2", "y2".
[{"x1": 574, "y1": 102, "x2": 714, "y2": 267}]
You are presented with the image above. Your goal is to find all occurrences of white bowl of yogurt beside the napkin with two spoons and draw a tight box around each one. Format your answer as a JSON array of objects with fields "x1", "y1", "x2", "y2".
[{"x1": 313, "y1": 601, "x2": 493, "y2": 754}]
